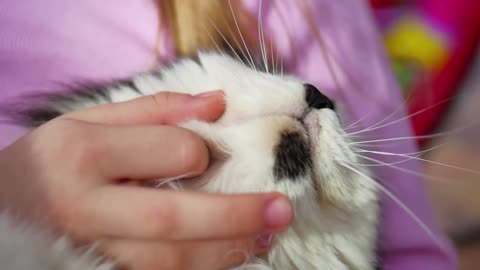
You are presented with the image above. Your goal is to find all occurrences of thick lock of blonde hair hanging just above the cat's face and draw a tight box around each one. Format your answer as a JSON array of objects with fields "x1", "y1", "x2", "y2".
[{"x1": 157, "y1": 0, "x2": 259, "y2": 56}]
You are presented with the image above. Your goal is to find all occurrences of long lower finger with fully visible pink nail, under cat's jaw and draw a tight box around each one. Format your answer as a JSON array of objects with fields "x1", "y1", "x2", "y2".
[{"x1": 72, "y1": 186, "x2": 293, "y2": 240}]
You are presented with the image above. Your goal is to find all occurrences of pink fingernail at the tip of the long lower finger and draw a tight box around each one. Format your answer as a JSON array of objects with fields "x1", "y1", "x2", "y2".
[{"x1": 265, "y1": 197, "x2": 292, "y2": 229}]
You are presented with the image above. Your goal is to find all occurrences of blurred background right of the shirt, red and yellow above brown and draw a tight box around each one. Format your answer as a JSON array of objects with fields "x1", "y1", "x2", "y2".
[{"x1": 371, "y1": 0, "x2": 480, "y2": 270}]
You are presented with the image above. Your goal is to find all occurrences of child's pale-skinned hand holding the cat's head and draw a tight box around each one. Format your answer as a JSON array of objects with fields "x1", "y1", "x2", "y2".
[{"x1": 0, "y1": 91, "x2": 293, "y2": 270}]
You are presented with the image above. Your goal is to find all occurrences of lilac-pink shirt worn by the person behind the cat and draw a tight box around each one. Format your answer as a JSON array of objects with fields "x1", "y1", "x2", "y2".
[{"x1": 0, "y1": 0, "x2": 456, "y2": 270}]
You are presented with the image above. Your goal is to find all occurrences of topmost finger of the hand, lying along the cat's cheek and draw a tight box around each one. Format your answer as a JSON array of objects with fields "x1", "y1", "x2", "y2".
[{"x1": 63, "y1": 90, "x2": 225, "y2": 125}]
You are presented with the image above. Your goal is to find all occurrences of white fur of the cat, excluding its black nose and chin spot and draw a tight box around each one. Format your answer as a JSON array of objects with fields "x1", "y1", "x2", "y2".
[{"x1": 0, "y1": 53, "x2": 378, "y2": 270}]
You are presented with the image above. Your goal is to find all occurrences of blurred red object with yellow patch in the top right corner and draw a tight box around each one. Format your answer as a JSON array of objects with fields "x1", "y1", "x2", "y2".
[{"x1": 371, "y1": 0, "x2": 480, "y2": 146}]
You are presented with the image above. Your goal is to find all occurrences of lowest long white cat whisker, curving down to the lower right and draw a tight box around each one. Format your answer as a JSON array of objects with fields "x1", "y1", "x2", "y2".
[{"x1": 340, "y1": 163, "x2": 447, "y2": 253}]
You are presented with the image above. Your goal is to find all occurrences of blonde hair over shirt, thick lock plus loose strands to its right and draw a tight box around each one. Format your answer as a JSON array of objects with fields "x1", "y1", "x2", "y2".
[{"x1": 155, "y1": 0, "x2": 343, "y2": 100}]
